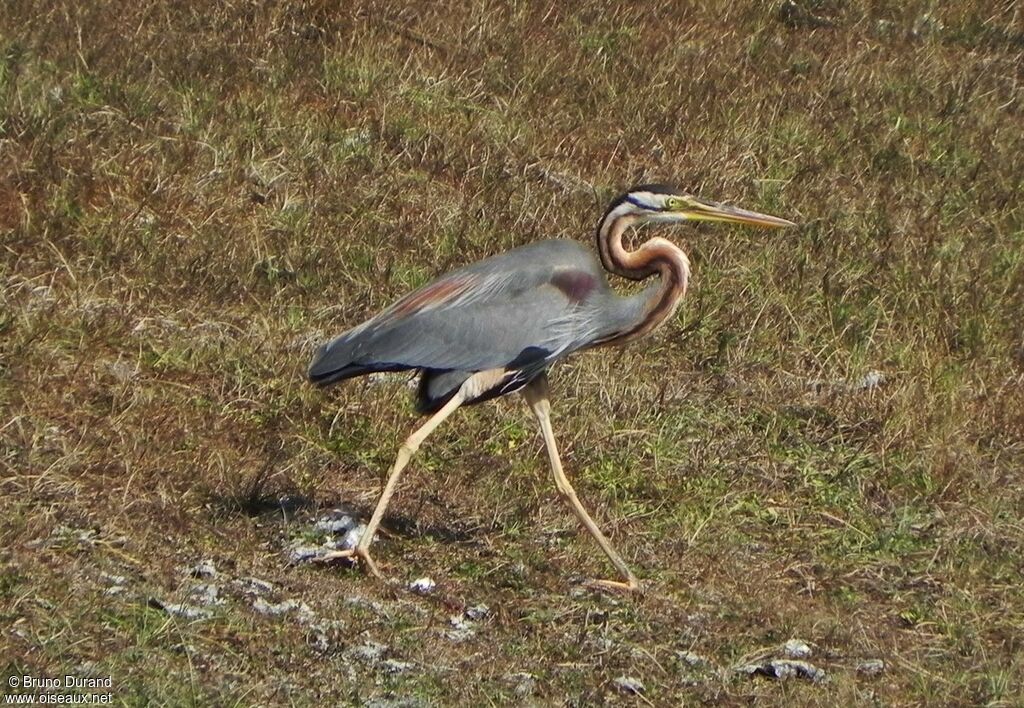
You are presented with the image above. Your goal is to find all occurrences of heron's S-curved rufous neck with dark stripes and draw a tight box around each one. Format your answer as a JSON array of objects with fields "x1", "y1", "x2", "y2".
[{"x1": 597, "y1": 207, "x2": 690, "y2": 342}]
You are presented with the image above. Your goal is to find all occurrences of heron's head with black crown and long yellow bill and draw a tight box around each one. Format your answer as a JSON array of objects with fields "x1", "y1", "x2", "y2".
[{"x1": 609, "y1": 184, "x2": 797, "y2": 228}]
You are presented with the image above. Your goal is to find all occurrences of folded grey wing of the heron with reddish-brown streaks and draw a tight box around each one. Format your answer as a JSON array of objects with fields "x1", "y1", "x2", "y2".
[{"x1": 309, "y1": 242, "x2": 607, "y2": 399}]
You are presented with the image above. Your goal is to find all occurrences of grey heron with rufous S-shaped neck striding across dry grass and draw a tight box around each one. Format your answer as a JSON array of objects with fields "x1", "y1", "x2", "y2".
[{"x1": 308, "y1": 184, "x2": 796, "y2": 591}]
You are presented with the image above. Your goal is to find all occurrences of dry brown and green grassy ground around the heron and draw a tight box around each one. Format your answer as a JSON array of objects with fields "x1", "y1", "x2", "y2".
[{"x1": 0, "y1": 0, "x2": 1024, "y2": 706}]
